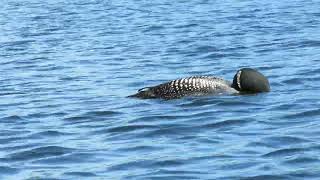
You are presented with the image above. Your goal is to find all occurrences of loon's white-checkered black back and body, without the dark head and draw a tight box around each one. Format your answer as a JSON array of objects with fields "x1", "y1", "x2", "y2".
[{"x1": 128, "y1": 76, "x2": 235, "y2": 99}]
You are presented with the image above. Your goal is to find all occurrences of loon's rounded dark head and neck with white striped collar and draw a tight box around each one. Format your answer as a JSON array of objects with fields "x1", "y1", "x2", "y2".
[{"x1": 231, "y1": 68, "x2": 270, "y2": 93}]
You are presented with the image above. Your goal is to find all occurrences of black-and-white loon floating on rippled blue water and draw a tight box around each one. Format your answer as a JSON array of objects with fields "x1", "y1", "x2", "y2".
[{"x1": 128, "y1": 68, "x2": 270, "y2": 99}]
